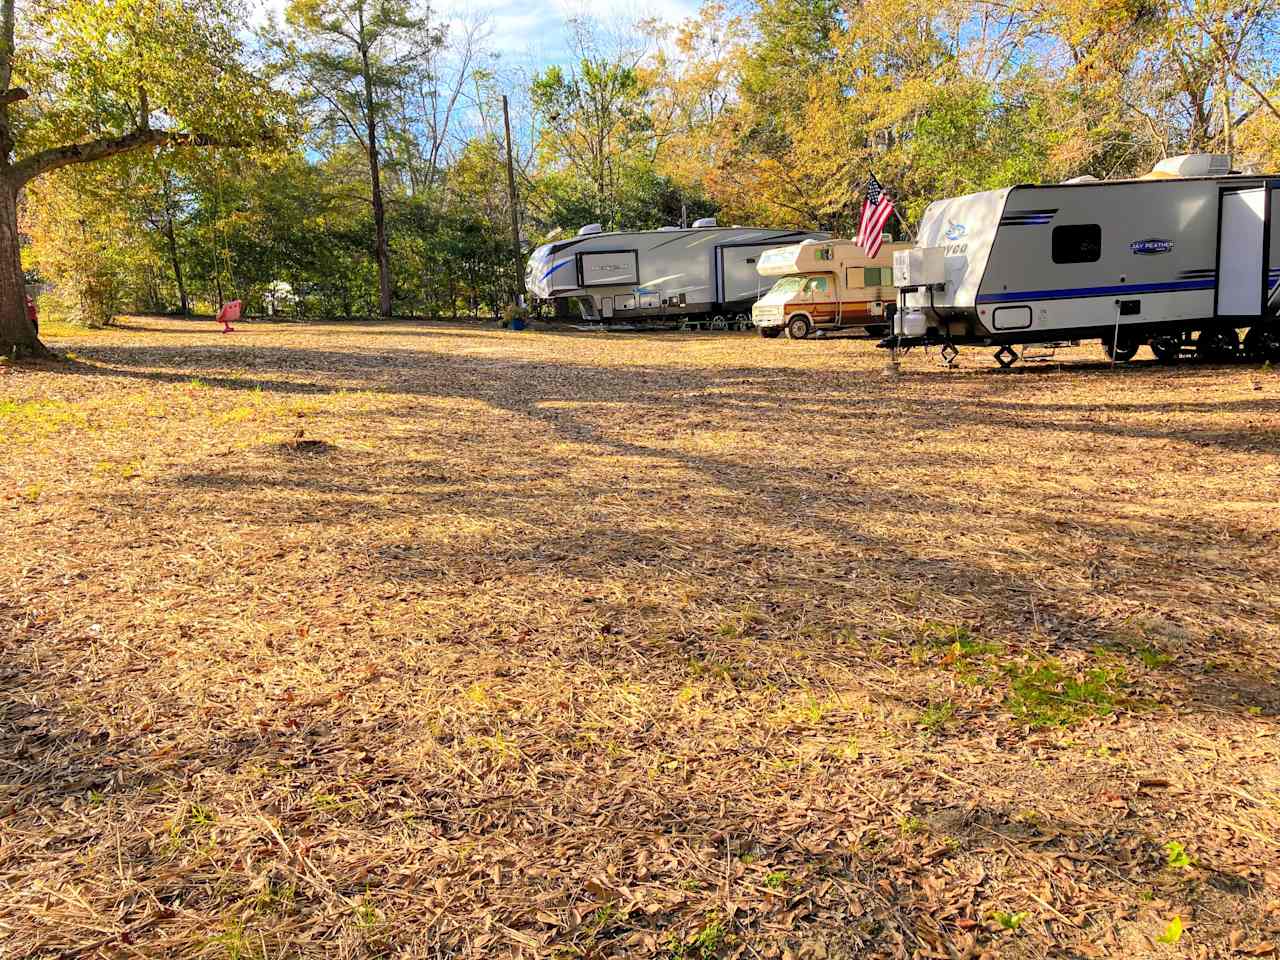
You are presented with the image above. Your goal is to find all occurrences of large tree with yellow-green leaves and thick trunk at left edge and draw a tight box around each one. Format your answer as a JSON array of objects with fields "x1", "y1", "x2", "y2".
[{"x1": 0, "y1": 0, "x2": 284, "y2": 356}]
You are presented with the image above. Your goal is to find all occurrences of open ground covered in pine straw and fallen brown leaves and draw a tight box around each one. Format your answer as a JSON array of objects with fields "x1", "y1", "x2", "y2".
[{"x1": 0, "y1": 319, "x2": 1280, "y2": 960}]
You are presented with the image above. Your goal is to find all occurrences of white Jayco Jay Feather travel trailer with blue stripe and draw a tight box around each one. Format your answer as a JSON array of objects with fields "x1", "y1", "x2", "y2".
[{"x1": 881, "y1": 155, "x2": 1280, "y2": 366}]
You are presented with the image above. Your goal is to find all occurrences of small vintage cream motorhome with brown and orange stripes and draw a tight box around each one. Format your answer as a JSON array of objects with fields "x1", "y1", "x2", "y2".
[{"x1": 751, "y1": 239, "x2": 910, "y2": 339}]
